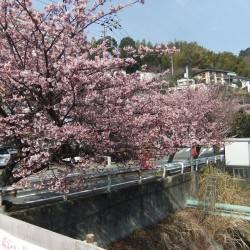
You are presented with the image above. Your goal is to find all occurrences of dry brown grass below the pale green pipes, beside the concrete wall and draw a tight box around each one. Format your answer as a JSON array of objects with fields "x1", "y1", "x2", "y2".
[{"x1": 107, "y1": 209, "x2": 250, "y2": 250}]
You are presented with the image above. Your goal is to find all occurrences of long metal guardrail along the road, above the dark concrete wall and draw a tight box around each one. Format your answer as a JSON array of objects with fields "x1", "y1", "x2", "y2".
[{"x1": 0, "y1": 155, "x2": 224, "y2": 207}]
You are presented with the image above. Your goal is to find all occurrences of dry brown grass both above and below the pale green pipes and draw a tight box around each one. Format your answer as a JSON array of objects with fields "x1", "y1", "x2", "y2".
[{"x1": 107, "y1": 166, "x2": 250, "y2": 250}]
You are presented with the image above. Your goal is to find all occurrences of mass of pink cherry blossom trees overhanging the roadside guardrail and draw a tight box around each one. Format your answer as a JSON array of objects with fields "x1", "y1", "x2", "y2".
[{"x1": 0, "y1": 0, "x2": 233, "y2": 192}]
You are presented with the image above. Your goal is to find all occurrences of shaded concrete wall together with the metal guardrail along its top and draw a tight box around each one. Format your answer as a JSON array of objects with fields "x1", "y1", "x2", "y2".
[{"x1": 1, "y1": 152, "x2": 224, "y2": 249}]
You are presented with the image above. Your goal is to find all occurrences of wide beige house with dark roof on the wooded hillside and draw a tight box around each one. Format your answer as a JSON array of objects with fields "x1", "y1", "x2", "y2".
[{"x1": 192, "y1": 68, "x2": 238, "y2": 85}]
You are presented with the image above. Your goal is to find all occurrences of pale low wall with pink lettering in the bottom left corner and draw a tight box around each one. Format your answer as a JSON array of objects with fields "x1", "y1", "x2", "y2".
[{"x1": 0, "y1": 214, "x2": 102, "y2": 250}]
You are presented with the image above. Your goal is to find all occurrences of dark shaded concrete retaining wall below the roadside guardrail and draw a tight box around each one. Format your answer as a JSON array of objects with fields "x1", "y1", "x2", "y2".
[{"x1": 9, "y1": 172, "x2": 197, "y2": 249}]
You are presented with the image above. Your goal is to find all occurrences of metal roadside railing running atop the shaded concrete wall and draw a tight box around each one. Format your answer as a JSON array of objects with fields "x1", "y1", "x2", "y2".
[{"x1": 0, "y1": 155, "x2": 224, "y2": 206}]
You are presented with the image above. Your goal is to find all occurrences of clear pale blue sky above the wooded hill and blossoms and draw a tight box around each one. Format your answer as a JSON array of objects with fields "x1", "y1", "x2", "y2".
[{"x1": 33, "y1": 0, "x2": 250, "y2": 55}]
